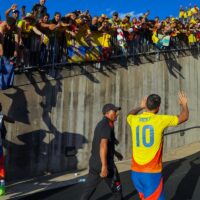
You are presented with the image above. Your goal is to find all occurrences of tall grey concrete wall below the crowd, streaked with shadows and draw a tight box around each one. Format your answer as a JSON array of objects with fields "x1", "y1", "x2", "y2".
[{"x1": 0, "y1": 52, "x2": 200, "y2": 180}]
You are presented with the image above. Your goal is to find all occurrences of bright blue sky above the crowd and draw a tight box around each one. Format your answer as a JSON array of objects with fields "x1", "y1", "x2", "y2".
[{"x1": 0, "y1": 0, "x2": 200, "y2": 19}]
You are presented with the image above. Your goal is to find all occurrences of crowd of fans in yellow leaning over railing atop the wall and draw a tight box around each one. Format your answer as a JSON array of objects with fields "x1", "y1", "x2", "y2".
[{"x1": 0, "y1": 0, "x2": 200, "y2": 67}]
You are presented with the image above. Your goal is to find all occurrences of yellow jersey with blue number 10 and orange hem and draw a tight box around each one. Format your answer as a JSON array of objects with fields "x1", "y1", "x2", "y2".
[{"x1": 127, "y1": 112, "x2": 178, "y2": 173}]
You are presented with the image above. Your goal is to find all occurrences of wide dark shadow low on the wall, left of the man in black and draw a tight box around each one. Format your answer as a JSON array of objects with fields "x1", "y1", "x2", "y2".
[{"x1": 4, "y1": 129, "x2": 87, "y2": 181}]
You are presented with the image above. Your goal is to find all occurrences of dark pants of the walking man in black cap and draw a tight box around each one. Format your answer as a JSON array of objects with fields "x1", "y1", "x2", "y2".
[{"x1": 81, "y1": 166, "x2": 122, "y2": 200}]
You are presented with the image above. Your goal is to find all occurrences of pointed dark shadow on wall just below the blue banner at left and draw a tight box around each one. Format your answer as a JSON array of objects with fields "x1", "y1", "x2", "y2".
[{"x1": 4, "y1": 87, "x2": 30, "y2": 124}]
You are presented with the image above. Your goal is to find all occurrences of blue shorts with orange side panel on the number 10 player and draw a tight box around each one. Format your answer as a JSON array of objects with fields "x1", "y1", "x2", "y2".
[{"x1": 131, "y1": 171, "x2": 165, "y2": 200}]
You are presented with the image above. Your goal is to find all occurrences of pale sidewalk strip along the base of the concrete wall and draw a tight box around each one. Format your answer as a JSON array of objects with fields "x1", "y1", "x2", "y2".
[{"x1": 0, "y1": 143, "x2": 200, "y2": 200}]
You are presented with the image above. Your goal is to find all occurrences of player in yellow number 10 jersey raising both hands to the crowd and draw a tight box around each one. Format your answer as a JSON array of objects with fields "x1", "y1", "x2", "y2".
[{"x1": 127, "y1": 92, "x2": 189, "y2": 200}]
